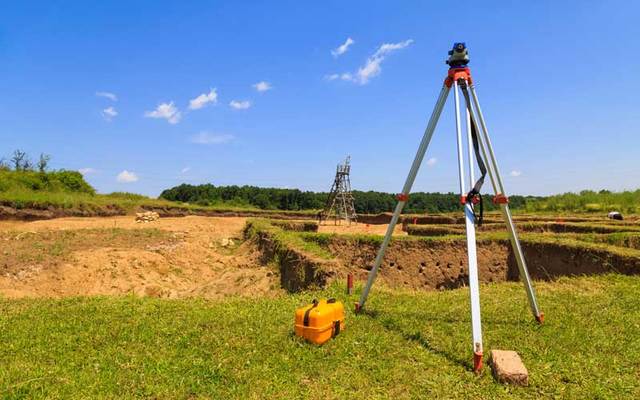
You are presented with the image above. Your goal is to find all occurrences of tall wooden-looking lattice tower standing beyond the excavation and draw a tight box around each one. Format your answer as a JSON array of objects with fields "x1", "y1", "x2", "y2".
[{"x1": 319, "y1": 156, "x2": 357, "y2": 223}]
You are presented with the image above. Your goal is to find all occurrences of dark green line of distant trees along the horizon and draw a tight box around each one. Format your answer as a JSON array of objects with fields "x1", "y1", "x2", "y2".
[{"x1": 160, "y1": 184, "x2": 540, "y2": 214}]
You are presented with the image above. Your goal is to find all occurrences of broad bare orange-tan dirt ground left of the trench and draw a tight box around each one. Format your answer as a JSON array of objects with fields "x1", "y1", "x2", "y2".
[{"x1": 0, "y1": 216, "x2": 281, "y2": 298}]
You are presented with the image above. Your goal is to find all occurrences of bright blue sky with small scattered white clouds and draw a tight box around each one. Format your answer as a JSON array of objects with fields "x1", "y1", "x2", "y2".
[{"x1": 0, "y1": 0, "x2": 640, "y2": 196}]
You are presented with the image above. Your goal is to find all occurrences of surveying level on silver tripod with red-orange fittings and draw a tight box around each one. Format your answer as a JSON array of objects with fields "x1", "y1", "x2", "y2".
[{"x1": 356, "y1": 43, "x2": 544, "y2": 372}]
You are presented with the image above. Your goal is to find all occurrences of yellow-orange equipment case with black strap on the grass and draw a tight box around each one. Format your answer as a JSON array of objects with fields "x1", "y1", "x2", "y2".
[{"x1": 295, "y1": 299, "x2": 344, "y2": 344}]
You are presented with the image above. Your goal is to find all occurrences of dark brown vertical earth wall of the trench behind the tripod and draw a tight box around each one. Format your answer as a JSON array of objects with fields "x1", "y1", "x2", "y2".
[{"x1": 272, "y1": 237, "x2": 640, "y2": 291}]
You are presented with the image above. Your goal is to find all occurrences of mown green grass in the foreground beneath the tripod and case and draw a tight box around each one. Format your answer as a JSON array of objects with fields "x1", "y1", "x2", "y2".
[{"x1": 0, "y1": 275, "x2": 640, "y2": 399}]
